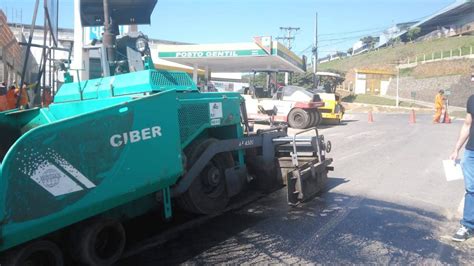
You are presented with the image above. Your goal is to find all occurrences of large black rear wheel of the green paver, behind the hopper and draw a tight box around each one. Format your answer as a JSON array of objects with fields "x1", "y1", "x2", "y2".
[{"x1": 178, "y1": 139, "x2": 234, "y2": 214}]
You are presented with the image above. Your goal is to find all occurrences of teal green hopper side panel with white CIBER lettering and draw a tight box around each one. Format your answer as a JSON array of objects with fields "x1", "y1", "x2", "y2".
[{"x1": 0, "y1": 91, "x2": 183, "y2": 249}]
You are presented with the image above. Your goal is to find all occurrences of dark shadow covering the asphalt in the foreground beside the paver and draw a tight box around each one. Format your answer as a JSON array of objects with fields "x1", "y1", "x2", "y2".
[{"x1": 119, "y1": 184, "x2": 466, "y2": 265}]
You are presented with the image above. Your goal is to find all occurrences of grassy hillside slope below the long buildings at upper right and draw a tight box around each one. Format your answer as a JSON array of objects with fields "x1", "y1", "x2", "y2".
[{"x1": 318, "y1": 36, "x2": 474, "y2": 72}]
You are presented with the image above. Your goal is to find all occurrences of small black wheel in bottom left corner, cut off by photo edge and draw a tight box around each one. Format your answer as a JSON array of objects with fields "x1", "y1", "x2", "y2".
[{"x1": 1, "y1": 240, "x2": 64, "y2": 266}]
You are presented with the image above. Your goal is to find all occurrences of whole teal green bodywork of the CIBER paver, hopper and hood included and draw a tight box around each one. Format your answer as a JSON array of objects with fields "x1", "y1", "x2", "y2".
[{"x1": 0, "y1": 70, "x2": 243, "y2": 251}]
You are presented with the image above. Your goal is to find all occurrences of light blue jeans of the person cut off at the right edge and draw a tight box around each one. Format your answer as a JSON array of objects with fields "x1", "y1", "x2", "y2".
[{"x1": 461, "y1": 150, "x2": 474, "y2": 230}]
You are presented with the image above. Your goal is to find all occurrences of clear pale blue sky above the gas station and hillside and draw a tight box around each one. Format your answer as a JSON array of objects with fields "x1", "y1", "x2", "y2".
[{"x1": 0, "y1": 0, "x2": 454, "y2": 56}]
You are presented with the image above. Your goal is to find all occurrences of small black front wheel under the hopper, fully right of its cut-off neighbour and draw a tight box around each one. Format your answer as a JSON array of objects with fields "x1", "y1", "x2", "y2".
[{"x1": 72, "y1": 219, "x2": 126, "y2": 265}]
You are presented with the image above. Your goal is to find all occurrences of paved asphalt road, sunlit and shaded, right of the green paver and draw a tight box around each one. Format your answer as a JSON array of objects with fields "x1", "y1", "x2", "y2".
[{"x1": 121, "y1": 114, "x2": 474, "y2": 265}]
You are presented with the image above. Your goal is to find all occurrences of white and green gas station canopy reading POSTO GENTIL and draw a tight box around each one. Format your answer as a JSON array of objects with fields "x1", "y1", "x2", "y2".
[{"x1": 153, "y1": 41, "x2": 306, "y2": 73}]
